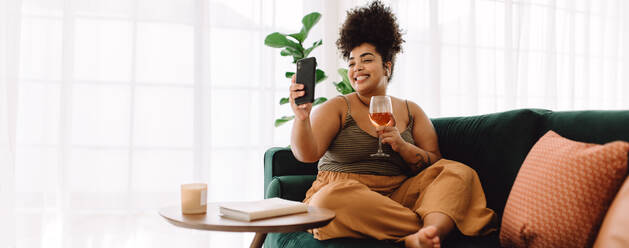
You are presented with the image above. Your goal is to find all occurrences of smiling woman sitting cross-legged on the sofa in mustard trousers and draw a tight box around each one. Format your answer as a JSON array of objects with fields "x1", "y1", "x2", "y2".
[{"x1": 290, "y1": 1, "x2": 495, "y2": 247}]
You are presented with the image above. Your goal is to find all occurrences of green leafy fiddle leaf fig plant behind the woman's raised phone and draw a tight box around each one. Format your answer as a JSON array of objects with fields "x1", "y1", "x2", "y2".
[{"x1": 264, "y1": 12, "x2": 354, "y2": 127}]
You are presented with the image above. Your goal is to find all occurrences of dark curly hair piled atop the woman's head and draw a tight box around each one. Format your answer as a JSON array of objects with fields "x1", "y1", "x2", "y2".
[{"x1": 336, "y1": 0, "x2": 404, "y2": 77}]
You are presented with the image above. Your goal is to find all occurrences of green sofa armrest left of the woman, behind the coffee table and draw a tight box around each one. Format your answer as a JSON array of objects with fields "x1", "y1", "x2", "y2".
[{"x1": 264, "y1": 147, "x2": 317, "y2": 200}]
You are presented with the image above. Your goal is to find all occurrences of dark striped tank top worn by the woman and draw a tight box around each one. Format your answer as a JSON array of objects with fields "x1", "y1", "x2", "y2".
[{"x1": 318, "y1": 96, "x2": 415, "y2": 176}]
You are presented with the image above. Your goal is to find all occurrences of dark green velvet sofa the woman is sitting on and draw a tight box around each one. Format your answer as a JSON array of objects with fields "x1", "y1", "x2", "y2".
[{"x1": 264, "y1": 109, "x2": 629, "y2": 248}]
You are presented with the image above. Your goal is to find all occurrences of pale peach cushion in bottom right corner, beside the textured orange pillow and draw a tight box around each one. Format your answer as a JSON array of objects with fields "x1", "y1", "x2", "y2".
[{"x1": 594, "y1": 179, "x2": 629, "y2": 248}]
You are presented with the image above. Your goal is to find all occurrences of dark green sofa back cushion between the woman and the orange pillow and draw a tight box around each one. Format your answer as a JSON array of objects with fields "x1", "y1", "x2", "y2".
[{"x1": 433, "y1": 109, "x2": 550, "y2": 219}]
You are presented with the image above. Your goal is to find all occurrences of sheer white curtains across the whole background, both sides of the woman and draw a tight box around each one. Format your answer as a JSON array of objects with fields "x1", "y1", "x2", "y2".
[{"x1": 0, "y1": 0, "x2": 629, "y2": 247}]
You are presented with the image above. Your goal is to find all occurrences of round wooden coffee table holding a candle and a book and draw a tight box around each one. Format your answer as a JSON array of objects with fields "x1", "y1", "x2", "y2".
[{"x1": 159, "y1": 203, "x2": 335, "y2": 247}]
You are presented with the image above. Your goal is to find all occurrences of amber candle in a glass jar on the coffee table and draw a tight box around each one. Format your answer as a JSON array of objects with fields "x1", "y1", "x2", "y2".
[{"x1": 181, "y1": 183, "x2": 207, "y2": 214}]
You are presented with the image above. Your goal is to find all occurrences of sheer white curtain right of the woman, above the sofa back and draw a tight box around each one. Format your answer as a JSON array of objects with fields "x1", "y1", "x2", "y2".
[{"x1": 382, "y1": 0, "x2": 629, "y2": 117}]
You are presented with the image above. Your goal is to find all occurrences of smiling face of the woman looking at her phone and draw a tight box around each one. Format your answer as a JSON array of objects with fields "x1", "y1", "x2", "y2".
[{"x1": 347, "y1": 43, "x2": 391, "y2": 96}]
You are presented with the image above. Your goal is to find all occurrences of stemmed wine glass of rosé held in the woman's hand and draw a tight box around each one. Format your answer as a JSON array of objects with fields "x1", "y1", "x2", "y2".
[{"x1": 369, "y1": 96, "x2": 393, "y2": 158}]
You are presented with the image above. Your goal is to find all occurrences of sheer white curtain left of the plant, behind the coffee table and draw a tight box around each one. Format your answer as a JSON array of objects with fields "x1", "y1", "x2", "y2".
[{"x1": 6, "y1": 0, "x2": 304, "y2": 247}]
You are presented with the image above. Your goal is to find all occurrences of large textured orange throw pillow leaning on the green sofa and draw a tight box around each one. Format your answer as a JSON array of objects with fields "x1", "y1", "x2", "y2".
[{"x1": 500, "y1": 131, "x2": 629, "y2": 247}]
